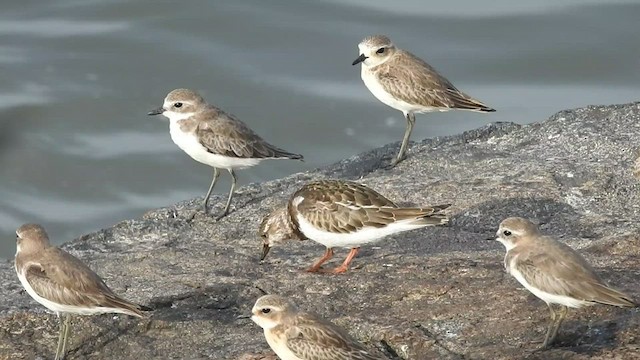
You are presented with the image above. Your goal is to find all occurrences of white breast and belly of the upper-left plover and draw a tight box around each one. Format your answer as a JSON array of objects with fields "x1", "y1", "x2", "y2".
[{"x1": 169, "y1": 122, "x2": 263, "y2": 170}]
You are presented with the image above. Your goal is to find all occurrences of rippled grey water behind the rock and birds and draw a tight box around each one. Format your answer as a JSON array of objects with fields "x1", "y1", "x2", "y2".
[{"x1": 0, "y1": 0, "x2": 640, "y2": 258}]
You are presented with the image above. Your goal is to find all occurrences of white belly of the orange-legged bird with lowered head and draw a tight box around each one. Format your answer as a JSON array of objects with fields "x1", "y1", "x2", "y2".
[{"x1": 296, "y1": 213, "x2": 424, "y2": 249}]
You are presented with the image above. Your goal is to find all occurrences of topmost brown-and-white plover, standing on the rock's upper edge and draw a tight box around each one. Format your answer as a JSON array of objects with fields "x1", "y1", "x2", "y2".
[{"x1": 352, "y1": 35, "x2": 495, "y2": 167}]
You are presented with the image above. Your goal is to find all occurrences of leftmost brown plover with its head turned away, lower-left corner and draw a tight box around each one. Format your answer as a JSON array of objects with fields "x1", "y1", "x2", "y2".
[{"x1": 16, "y1": 224, "x2": 146, "y2": 360}]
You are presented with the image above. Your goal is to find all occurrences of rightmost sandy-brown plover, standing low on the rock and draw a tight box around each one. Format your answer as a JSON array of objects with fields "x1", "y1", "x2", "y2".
[{"x1": 496, "y1": 217, "x2": 638, "y2": 348}]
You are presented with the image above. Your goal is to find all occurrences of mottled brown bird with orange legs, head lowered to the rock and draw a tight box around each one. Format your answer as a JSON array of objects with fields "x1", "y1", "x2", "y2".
[{"x1": 259, "y1": 180, "x2": 450, "y2": 273}]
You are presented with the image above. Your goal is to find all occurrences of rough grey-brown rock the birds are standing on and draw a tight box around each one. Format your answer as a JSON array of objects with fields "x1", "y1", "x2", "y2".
[{"x1": 0, "y1": 103, "x2": 640, "y2": 360}]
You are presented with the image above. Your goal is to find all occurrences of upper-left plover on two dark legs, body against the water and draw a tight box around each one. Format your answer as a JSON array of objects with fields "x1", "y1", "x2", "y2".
[{"x1": 148, "y1": 89, "x2": 302, "y2": 219}]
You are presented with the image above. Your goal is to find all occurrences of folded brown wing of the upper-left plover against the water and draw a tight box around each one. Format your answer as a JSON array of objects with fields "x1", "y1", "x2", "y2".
[{"x1": 195, "y1": 108, "x2": 302, "y2": 159}]
